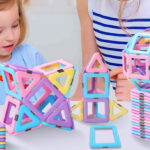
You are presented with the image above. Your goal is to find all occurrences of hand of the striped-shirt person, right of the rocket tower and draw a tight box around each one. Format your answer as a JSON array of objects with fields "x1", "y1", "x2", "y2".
[{"x1": 110, "y1": 67, "x2": 135, "y2": 101}]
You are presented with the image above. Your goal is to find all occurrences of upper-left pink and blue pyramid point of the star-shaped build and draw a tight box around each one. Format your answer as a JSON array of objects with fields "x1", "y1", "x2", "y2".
[{"x1": 0, "y1": 64, "x2": 42, "y2": 100}]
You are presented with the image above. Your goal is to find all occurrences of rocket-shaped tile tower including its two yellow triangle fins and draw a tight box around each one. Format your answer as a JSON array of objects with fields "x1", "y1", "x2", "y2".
[{"x1": 71, "y1": 53, "x2": 128, "y2": 123}]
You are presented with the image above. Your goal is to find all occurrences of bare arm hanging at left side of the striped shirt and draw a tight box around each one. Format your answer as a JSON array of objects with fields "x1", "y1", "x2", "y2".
[{"x1": 71, "y1": 0, "x2": 98, "y2": 100}]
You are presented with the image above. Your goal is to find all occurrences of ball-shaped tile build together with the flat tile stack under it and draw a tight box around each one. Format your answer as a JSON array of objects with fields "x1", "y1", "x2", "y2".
[{"x1": 123, "y1": 32, "x2": 150, "y2": 141}]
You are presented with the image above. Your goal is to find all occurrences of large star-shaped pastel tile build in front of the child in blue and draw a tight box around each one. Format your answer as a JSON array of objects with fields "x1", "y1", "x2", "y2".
[{"x1": 0, "y1": 59, "x2": 76, "y2": 135}]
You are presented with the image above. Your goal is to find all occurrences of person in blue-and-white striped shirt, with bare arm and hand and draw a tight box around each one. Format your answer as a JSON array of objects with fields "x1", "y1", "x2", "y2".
[{"x1": 72, "y1": 0, "x2": 150, "y2": 101}]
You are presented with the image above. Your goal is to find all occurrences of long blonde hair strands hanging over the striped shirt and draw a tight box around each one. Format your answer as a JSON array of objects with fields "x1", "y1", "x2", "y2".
[{"x1": 118, "y1": 0, "x2": 141, "y2": 36}]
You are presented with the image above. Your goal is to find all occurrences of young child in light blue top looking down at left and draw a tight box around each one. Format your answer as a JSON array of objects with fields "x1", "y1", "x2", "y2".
[{"x1": 0, "y1": 0, "x2": 45, "y2": 104}]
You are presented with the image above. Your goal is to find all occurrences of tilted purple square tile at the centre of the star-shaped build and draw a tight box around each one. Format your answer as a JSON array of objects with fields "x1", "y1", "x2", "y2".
[{"x1": 23, "y1": 78, "x2": 65, "y2": 121}]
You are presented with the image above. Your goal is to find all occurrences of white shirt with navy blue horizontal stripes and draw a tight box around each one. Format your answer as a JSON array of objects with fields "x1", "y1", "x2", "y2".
[{"x1": 88, "y1": 0, "x2": 150, "y2": 89}]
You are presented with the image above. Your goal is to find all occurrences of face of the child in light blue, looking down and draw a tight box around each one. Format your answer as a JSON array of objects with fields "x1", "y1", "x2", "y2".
[{"x1": 0, "y1": 4, "x2": 20, "y2": 62}]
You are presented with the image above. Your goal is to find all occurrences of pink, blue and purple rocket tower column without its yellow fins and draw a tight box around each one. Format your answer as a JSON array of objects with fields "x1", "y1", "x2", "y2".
[{"x1": 82, "y1": 53, "x2": 109, "y2": 123}]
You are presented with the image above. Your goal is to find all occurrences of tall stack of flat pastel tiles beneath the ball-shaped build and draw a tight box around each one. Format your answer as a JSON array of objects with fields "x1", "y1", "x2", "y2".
[{"x1": 131, "y1": 89, "x2": 150, "y2": 141}]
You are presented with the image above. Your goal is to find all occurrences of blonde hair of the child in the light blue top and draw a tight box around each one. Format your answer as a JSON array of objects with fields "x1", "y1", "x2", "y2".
[{"x1": 0, "y1": 0, "x2": 27, "y2": 45}]
